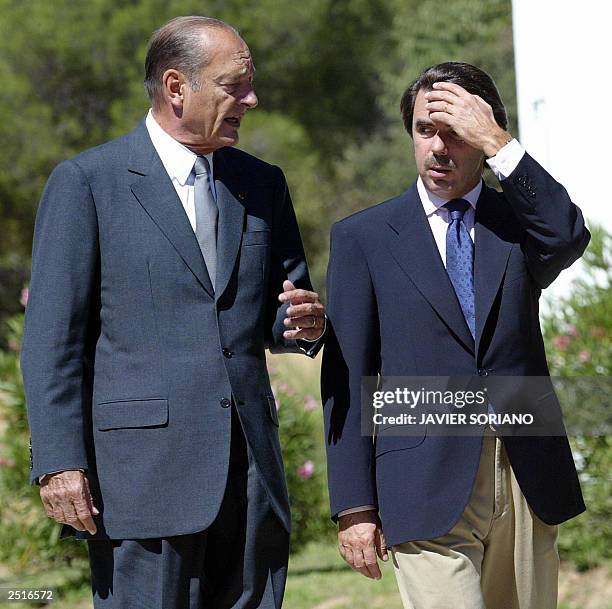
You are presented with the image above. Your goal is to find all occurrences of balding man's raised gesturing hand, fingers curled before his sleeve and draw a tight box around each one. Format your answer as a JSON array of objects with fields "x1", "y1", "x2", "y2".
[{"x1": 278, "y1": 280, "x2": 325, "y2": 340}]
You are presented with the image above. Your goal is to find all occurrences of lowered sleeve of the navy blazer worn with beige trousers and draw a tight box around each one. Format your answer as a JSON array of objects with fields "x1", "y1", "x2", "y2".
[{"x1": 321, "y1": 223, "x2": 380, "y2": 519}]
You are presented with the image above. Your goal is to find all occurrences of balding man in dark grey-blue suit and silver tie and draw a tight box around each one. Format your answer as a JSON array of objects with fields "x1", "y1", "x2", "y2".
[{"x1": 22, "y1": 16, "x2": 324, "y2": 609}]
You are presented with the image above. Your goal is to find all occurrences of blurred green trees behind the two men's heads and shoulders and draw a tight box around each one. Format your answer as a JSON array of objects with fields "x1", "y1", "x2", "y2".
[{"x1": 0, "y1": 0, "x2": 515, "y2": 291}]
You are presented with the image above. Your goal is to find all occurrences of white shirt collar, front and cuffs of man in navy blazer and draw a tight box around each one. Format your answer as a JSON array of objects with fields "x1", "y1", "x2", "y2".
[{"x1": 338, "y1": 139, "x2": 525, "y2": 516}]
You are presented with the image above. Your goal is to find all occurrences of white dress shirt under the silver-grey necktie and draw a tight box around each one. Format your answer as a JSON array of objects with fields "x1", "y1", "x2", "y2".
[{"x1": 145, "y1": 110, "x2": 216, "y2": 232}]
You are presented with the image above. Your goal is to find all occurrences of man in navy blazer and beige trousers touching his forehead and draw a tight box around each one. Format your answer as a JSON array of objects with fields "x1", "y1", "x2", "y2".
[{"x1": 322, "y1": 62, "x2": 589, "y2": 609}]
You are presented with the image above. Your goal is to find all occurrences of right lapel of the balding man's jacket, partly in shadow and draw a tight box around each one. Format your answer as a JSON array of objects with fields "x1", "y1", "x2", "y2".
[{"x1": 213, "y1": 149, "x2": 246, "y2": 299}]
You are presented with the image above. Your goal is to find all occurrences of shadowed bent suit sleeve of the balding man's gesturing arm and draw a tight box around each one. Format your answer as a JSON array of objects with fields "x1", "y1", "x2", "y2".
[{"x1": 266, "y1": 167, "x2": 324, "y2": 357}]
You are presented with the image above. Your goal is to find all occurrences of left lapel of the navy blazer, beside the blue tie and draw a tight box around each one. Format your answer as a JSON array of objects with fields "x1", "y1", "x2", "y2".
[{"x1": 387, "y1": 184, "x2": 474, "y2": 353}]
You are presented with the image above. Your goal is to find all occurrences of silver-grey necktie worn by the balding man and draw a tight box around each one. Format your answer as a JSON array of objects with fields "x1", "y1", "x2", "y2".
[{"x1": 193, "y1": 156, "x2": 219, "y2": 290}]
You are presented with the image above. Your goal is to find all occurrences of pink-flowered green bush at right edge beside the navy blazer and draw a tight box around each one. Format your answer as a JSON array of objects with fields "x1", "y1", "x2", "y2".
[{"x1": 544, "y1": 228, "x2": 612, "y2": 569}]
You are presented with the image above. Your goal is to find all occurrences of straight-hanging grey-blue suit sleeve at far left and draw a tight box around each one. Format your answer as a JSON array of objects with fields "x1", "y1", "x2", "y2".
[{"x1": 21, "y1": 161, "x2": 99, "y2": 482}]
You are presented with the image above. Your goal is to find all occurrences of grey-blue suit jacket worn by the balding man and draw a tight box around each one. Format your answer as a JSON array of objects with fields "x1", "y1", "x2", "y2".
[{"x1": 21, "y1": 123, "x2": 320, "y2": 538}]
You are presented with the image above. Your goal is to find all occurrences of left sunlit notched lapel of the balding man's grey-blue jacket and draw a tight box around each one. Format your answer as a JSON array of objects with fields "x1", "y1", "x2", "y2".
[{"x1": 128, "y1": 123, "x2": 214, "y2": 298}]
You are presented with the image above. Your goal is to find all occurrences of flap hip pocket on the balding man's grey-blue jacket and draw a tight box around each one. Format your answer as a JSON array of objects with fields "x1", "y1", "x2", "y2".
[{"x1": 93, "y1": 398, "x2": 168, "y2": 431}]
